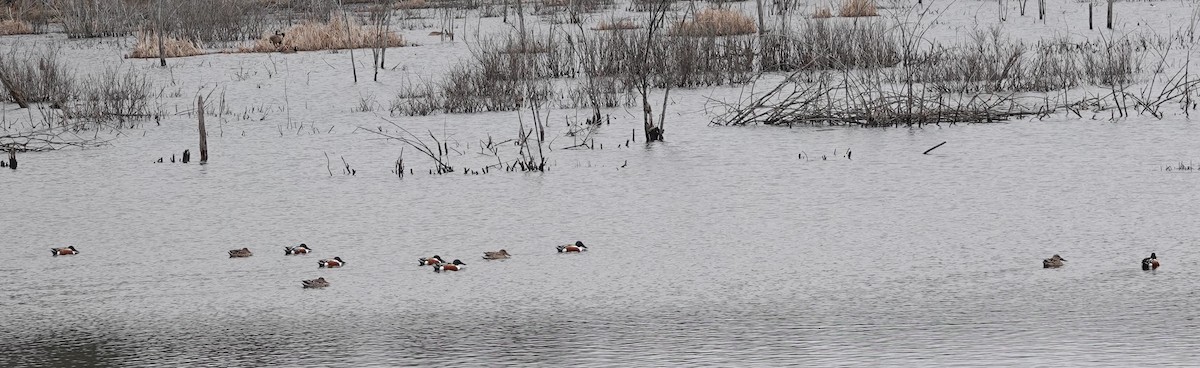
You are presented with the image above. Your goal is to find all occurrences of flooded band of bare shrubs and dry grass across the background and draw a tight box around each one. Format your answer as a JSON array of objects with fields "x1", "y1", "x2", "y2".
[{"x1": 0, "y1": 0, "x2": 1200, "y2": 170}]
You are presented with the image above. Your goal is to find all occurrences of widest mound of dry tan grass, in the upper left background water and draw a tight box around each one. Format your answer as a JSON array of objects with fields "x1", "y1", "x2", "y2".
[{"x1": 238, "y1": 17, "x2": 404, "y2": 53}]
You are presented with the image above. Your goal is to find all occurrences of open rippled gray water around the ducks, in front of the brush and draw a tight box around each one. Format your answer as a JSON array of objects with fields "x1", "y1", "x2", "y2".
[{"x1": 0, "y1": 114, "x2": 1200, "y2": 367}]
